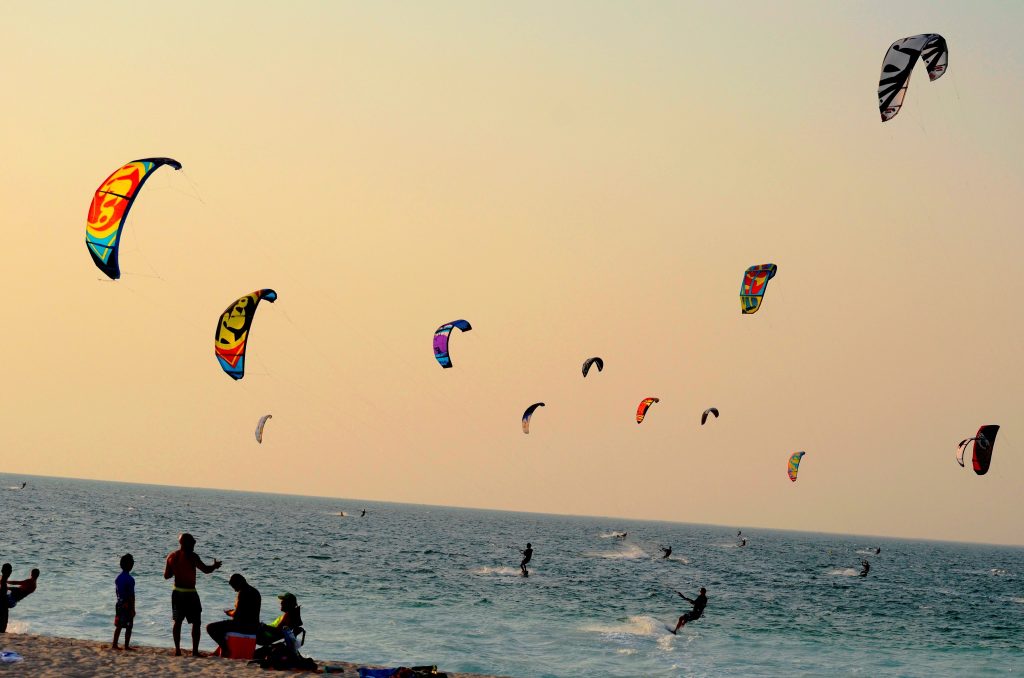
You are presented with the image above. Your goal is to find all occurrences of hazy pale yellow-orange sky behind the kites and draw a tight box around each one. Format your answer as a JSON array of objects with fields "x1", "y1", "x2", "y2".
[{"x1": 0, "y1": 1, "x2": 1024, "y2": 544}]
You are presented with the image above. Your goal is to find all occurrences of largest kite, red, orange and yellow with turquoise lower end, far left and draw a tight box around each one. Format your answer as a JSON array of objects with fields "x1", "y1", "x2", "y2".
[{"x1": 85, "y1": 158, "x2": 181, "y2": 281}]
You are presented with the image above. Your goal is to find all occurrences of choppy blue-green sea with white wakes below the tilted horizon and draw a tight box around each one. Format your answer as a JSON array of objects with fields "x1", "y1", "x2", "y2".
[{"x1": 0, "y1": 474, "x2": 1024, "y2": 677}]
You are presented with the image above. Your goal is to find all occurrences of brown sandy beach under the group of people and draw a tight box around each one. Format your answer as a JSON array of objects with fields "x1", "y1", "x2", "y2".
[{"x1": 0, "y1": 629, "x2": 502, "y2": 678}]
